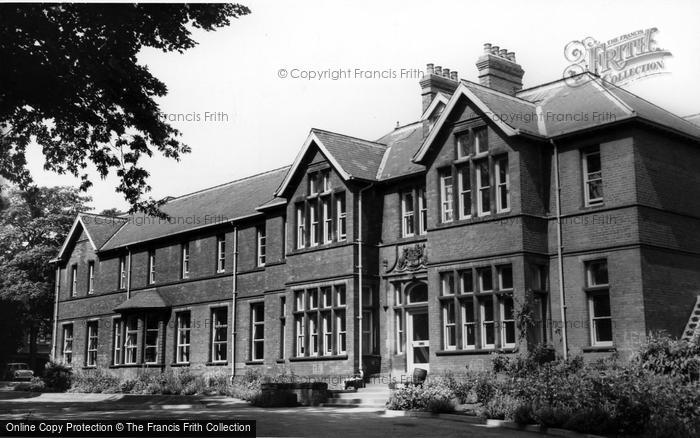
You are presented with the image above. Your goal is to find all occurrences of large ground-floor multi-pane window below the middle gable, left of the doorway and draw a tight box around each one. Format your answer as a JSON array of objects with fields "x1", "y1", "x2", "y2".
[{"x1": 294, "y1": 284, "x2": 347, "y2": 357}]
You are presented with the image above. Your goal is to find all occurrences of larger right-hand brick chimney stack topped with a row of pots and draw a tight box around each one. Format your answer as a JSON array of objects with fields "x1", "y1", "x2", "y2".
[{"x1": 476, "y1": 43, "x2": 525, "y2": 95}]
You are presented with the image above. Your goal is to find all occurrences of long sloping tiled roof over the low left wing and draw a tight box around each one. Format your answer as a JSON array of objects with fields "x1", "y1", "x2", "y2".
[{"x1": 100, "y1": 166, "x2": 289, "y2": 251}]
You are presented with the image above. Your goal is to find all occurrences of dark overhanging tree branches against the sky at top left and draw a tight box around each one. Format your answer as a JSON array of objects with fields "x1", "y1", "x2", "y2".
[{"x1": 0, "y1": 3, "x2": 250, "y2": 216}]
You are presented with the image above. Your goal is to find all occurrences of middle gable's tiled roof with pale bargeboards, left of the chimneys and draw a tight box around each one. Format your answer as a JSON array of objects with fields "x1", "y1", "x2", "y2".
[{"x1": 275, "y1": 128, "x2": 386, "y2": 197}]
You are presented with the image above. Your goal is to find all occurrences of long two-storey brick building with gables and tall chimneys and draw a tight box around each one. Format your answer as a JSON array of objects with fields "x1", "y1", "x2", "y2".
[{"x1": 54, "y1": 45, "x2": 700, "y2": 375}]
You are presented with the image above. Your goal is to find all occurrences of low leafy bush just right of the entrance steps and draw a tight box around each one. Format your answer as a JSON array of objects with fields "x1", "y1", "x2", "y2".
[{"x1": 386, "y1": 382, "x2": 455, "y2": 412}]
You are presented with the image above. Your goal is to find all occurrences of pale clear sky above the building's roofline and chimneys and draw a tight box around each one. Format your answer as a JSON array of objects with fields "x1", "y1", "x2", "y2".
[{"x1": 28, "y1": 0, "x2": 700, "y2": 211}]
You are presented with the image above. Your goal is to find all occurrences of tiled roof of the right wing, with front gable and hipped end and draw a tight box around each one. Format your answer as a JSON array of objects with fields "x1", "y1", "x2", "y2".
[{"x1": 413, "y1": 72, "x2": 700, "y2": 163}]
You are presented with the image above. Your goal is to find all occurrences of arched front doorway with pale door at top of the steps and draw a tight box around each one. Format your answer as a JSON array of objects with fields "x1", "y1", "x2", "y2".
[{"x1": 406, "y1": 282, "x2": 430, "y2": 373}]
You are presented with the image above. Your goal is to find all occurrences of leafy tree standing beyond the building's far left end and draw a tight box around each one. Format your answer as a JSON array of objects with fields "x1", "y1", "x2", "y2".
[{"x1": 0, "y1": 187, "x2": 90, "y2": 368}]
